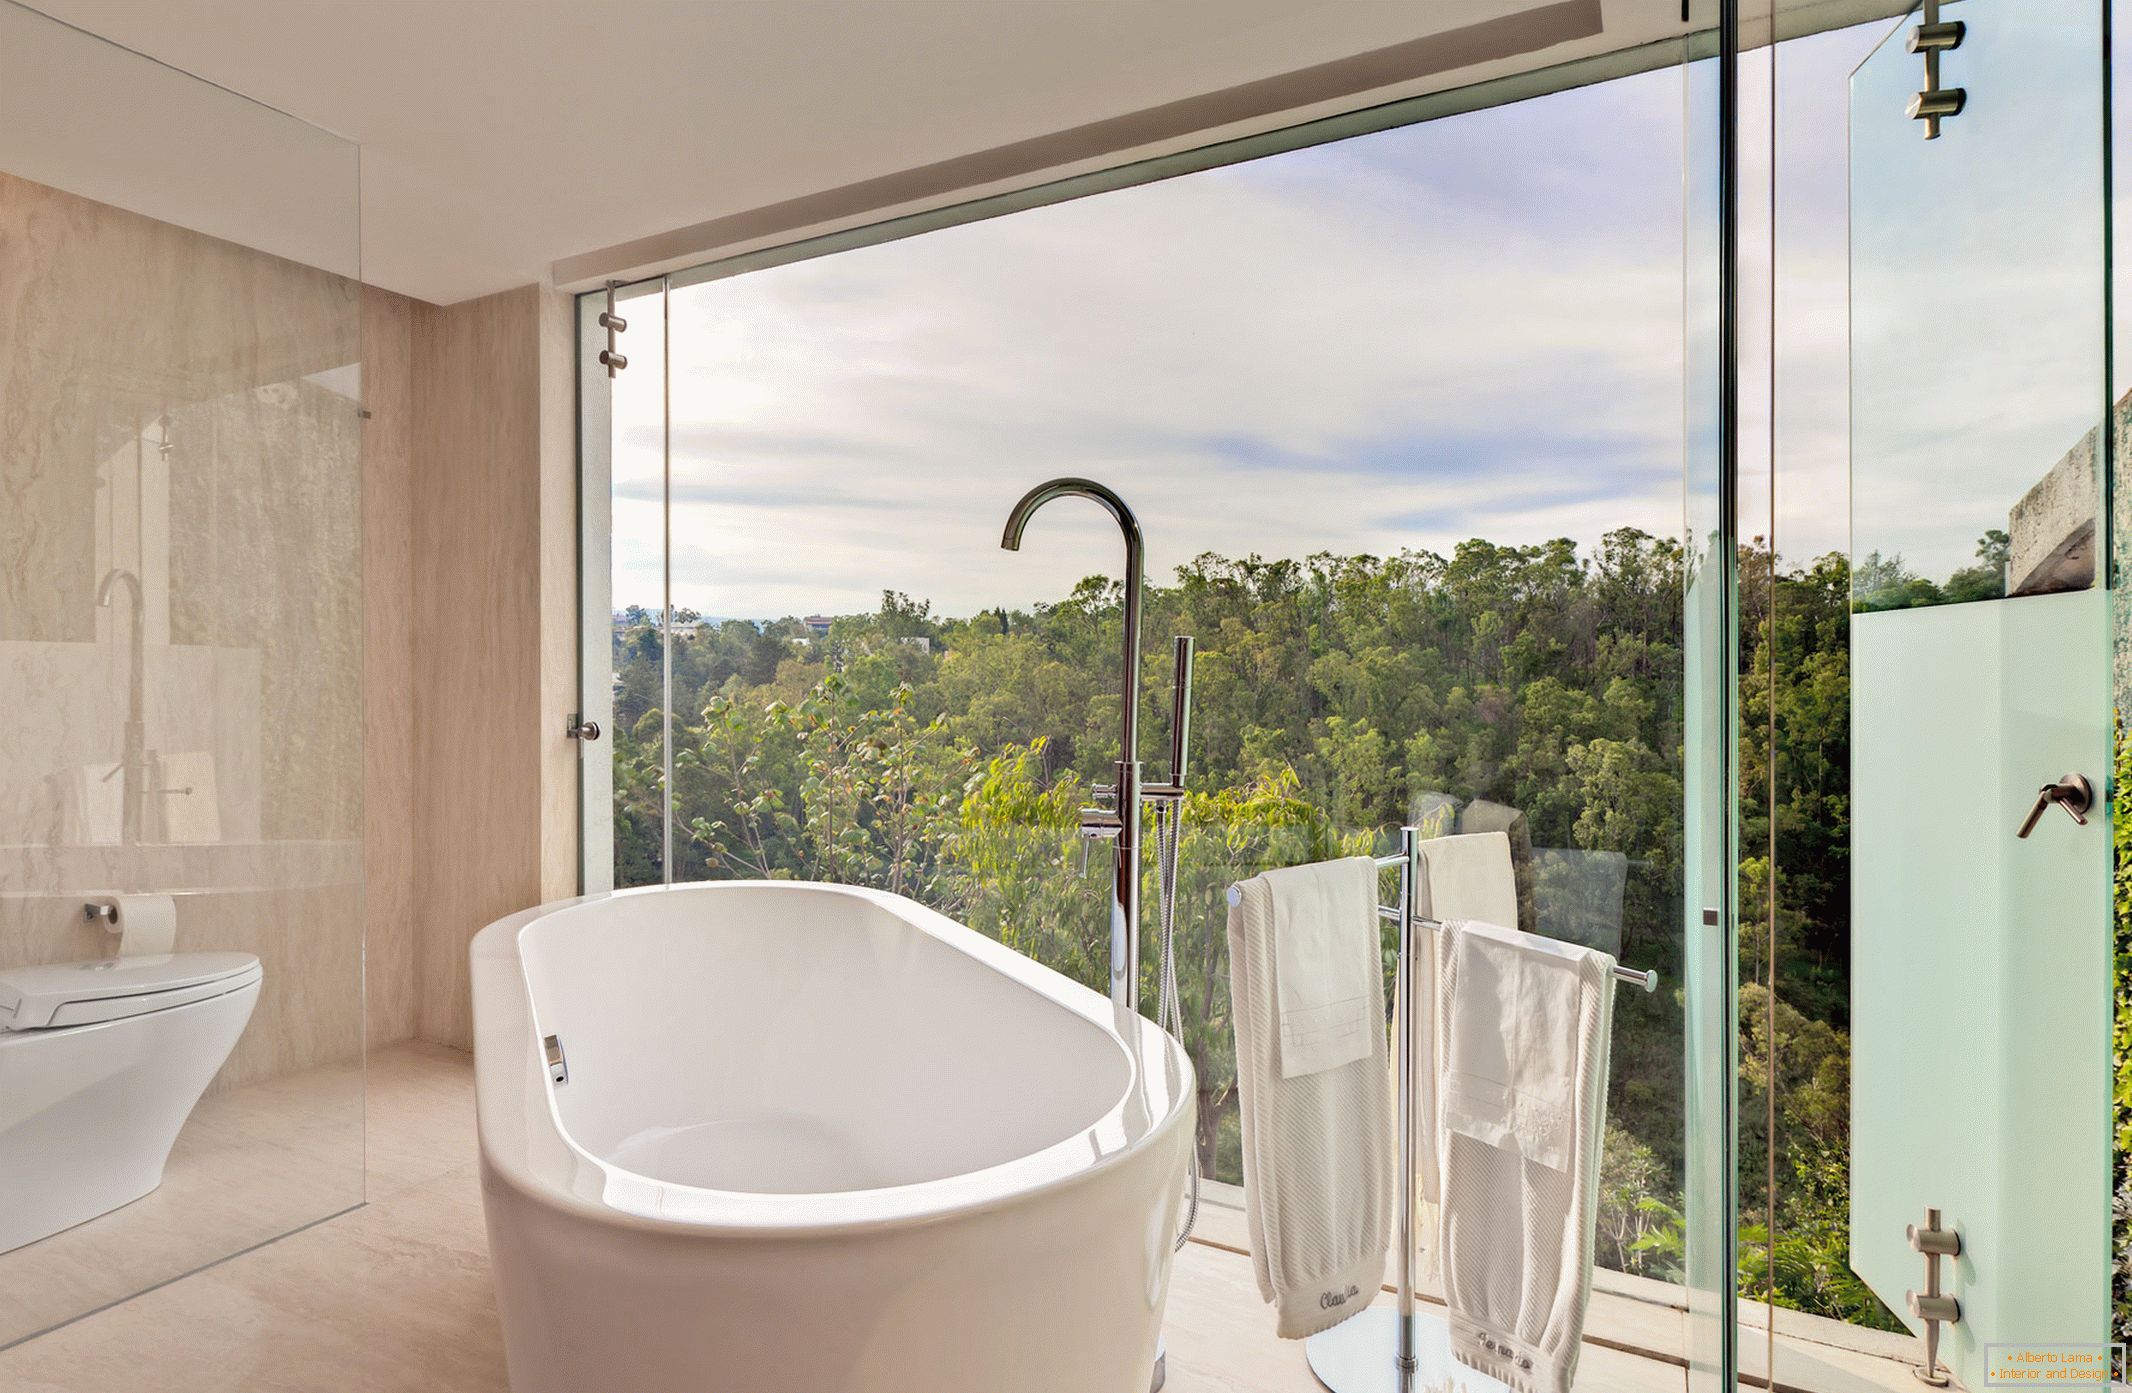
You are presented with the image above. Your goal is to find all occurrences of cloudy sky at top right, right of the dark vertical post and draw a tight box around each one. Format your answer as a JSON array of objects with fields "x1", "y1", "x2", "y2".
[{"x1": 1742, "y1": 0, "x2": 2106, "y2": 580}]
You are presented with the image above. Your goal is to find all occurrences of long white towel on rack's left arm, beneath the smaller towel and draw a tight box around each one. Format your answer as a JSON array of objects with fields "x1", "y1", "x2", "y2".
[{"x1": 1228, "y1": 860, "x2": 1394, "y2": 1340}]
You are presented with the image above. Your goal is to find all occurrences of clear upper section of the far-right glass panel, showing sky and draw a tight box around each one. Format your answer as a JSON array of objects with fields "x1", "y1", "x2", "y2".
[{"x1": 1851, "y1": 0, "x2": 2106, "y2": 610}]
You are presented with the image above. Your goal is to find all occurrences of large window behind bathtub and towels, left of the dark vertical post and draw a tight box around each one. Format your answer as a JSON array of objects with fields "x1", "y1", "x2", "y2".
[{"x1": 586, "y1": 24, "x2": 1748, "y2": 1382}]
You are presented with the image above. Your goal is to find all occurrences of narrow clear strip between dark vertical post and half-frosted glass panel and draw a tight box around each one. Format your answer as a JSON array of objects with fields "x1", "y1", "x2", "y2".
[{"x1": 1738, "y1": 21, "x2": 1919, "y2": 1389}]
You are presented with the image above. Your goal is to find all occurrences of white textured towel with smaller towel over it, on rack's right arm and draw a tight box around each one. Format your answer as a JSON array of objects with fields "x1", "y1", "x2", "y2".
[{"x1": 1433, "y1": 922, "x2": 1614, "y2": 1393}]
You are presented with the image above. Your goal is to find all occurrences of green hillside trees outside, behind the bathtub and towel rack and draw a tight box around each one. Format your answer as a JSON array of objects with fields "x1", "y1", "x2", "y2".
[{"x1": 614, "y1": 529, "x2": 1884, "y2": 1323}]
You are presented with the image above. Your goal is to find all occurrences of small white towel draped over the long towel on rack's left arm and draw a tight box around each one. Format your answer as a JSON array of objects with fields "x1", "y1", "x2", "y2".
[{"x1": 1258, "y1": 858, "x2": 1384, "y2": 1079}]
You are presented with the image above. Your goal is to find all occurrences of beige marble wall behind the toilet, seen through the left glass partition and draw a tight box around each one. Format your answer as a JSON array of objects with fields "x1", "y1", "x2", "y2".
[{"x1": 0, "y1": 175, "x2": 367, "y2": 1088}]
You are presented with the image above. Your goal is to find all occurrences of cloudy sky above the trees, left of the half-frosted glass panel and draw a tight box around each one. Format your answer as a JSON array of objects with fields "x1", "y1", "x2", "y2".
[{"x1": 612, "y1": 13, "x2": 2091, "y2": 619}]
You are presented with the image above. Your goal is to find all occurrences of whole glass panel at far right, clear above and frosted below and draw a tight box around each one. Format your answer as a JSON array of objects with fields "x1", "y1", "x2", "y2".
[{"x1": 1851, "y1": 0, "x2": 2111, "y2": 1387}]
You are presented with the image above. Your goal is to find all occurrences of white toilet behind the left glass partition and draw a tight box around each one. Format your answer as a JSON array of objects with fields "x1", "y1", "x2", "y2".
[{"x1": 0, "y1": 954, "x2": 260, "y2": 1252}]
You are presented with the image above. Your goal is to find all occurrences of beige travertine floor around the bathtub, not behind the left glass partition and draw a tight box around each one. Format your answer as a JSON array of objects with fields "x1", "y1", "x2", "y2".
[{"x1": 0, "y1": 1045, "x2": 1686, "y2": 1393}]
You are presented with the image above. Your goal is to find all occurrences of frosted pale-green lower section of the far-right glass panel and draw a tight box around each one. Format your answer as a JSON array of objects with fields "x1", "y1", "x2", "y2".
[{"x1": 1851, "y1": 591, "x2": 2111, "y2": 1389}]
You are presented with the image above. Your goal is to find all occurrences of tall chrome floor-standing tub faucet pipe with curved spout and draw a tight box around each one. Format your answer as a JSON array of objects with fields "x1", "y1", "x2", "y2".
[{"x1": 1000, "y1": 478, "x2": 1147, "y2": 1011}]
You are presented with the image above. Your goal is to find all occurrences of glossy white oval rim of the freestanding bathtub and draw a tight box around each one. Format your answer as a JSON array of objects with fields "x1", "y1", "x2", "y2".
[{"x1": 469, "y1": 881, "x2": 1198, "y2": 1239}]
